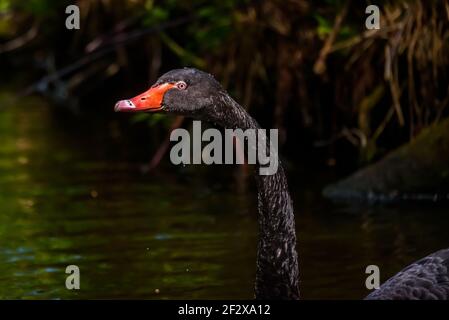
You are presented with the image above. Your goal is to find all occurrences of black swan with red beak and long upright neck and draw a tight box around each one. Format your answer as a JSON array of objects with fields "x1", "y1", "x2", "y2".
[{"x1": 115, "y1": 68, "x2": 449, "y2": 299}]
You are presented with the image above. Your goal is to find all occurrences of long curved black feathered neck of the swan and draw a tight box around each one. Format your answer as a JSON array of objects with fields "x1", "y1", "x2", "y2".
[{"x1": 211, "y1": 94, "x2": 299, "y2": 299}]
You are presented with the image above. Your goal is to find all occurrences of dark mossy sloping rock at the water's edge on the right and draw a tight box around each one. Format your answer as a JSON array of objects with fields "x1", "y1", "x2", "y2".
[{"x1": 323, "y1": 119, "x2": 449, "y2": 201}]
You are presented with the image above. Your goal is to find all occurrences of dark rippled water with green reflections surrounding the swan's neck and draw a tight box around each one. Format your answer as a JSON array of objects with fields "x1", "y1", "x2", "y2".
[{"x1": 0, "y1": 92, "x2": 449, "y2": 299}]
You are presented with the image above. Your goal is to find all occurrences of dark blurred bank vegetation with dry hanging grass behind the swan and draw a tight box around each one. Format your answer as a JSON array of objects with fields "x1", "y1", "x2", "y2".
[{"x1": 0, "y1": 0, "x2": 449, "y2": 169}]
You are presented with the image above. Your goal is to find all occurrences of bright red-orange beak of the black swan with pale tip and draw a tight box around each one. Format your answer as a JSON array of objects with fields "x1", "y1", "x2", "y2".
[{"x1": 114, "y1": 83, "x2": 175, "y2": 112}]
